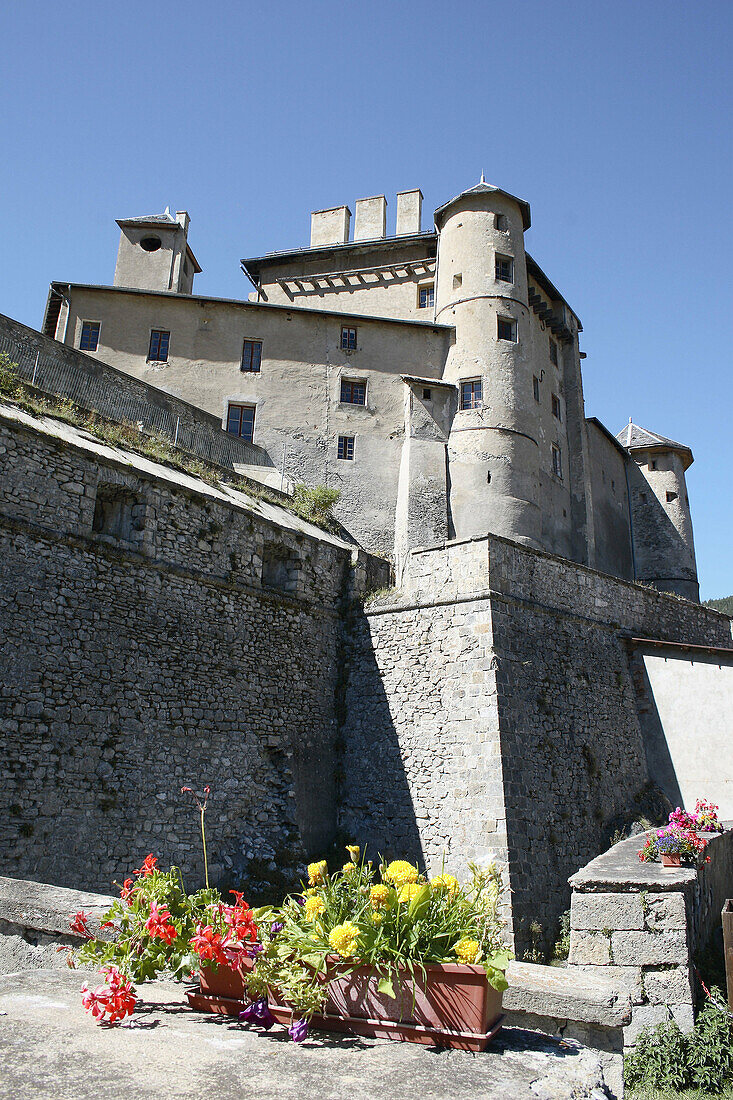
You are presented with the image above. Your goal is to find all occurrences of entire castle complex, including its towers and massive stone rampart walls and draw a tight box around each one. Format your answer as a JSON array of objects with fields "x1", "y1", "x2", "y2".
[{"x1": 0, "y1": 182, "x2": 733, "y2": 945}]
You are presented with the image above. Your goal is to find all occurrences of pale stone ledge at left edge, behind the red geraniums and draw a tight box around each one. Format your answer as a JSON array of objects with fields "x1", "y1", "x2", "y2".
[{"x1": 0, "y1": 877, "x2": 114, "y2": 941}]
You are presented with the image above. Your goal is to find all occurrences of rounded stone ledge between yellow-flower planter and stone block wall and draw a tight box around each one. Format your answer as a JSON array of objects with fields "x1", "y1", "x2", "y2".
[{"x1": 503, "y1": 963, "x2": 632, "y2": 1027}]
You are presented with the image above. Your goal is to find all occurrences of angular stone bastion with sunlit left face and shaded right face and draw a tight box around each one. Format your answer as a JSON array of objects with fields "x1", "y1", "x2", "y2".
[{"x1": 342, "y1": 537, "x2": 731, "y2": 949}]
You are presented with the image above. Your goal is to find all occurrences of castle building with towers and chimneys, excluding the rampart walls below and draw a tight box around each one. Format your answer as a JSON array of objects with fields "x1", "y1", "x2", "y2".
[{"x1": 44, "y1": 180, "x2": 698, "y2": 600}]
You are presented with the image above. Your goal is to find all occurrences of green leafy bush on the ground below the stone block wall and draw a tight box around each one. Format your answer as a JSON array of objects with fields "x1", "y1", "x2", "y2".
[{"x1": 624, "y1": 990, "x2": 733, "y2": 1096}]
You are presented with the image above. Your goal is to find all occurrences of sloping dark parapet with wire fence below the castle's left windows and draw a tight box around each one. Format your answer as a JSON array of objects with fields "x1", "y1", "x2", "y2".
[{"x1": 0, "y1": 322, "x2": 272, "y2": 469}]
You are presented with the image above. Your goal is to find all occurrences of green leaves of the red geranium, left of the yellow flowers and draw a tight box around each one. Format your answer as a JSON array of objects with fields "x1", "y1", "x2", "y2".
[{"x1": 70, "y1": 867, "x2": 221, "y2": 982}]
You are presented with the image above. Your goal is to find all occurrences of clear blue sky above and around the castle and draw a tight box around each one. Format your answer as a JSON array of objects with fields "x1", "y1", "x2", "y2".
[{"x1": 0, "y1": 0, "x2": 733, "y2": 597}]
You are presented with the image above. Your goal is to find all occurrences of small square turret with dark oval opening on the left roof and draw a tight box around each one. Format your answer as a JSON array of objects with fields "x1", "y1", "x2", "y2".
[{"x1": 114, "y1": 207, "x2": 201, "y2": 294}]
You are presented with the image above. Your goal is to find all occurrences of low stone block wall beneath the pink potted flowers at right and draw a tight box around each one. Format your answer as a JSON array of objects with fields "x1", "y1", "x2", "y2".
[{"x1": 568, "y1": 833, "x2": 733, "y2": 1046}]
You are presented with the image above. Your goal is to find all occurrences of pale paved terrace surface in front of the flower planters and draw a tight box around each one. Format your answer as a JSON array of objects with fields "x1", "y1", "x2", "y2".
[{"x1": 0, "y1": 969, "x2": 608, "y2": 1100}]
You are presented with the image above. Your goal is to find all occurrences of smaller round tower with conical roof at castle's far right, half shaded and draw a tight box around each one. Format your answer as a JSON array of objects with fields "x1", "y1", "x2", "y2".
[{"x1": 616, "y1": 420, "x2": 700, "y2": 601}]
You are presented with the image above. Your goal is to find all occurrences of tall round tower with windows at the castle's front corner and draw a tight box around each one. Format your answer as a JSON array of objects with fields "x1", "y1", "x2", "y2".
[{"x1": 435, "y1": 180, "x2": 541, "y2": 547}]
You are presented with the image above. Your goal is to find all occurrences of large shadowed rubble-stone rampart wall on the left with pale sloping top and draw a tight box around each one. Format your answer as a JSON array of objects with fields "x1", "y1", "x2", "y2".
[{"x1": 0, "y1": 413, "x2": 350, "y2": 893}]
